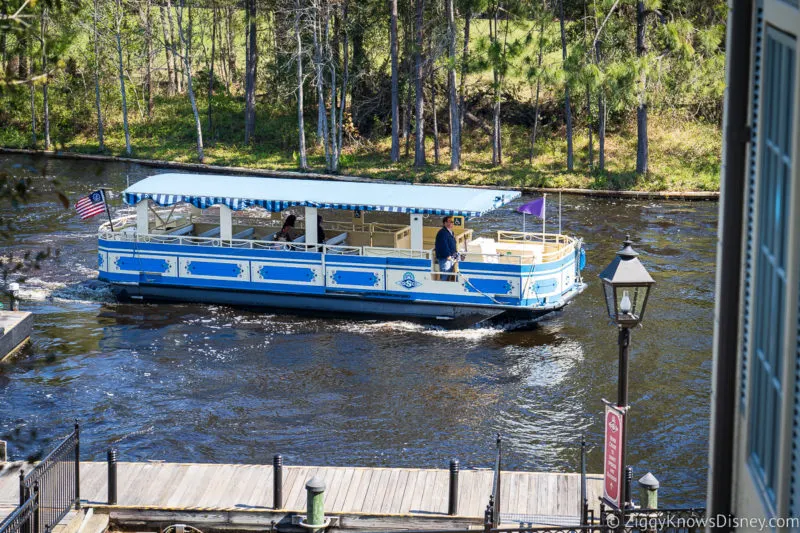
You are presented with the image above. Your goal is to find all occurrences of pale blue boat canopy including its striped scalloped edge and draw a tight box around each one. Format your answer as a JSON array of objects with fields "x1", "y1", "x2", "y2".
[{"x1": 124, "y1": 173, "x2": 521, "y2": 217}]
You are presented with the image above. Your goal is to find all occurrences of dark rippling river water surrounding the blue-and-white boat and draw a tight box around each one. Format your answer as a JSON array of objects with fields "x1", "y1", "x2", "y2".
[{"x1": 0, "y1": 155, "x2": 718, "y2": 506}]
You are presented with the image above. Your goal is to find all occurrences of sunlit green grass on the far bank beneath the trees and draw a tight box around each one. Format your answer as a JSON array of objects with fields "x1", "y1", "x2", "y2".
[{"x1": 0, "y1": 96, "x2": 721, "y2": 191}]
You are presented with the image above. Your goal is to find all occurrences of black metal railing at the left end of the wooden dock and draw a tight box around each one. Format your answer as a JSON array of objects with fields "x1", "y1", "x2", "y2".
[{"x1": 19, "y1": 423, "x2": 80, "y2": 533}]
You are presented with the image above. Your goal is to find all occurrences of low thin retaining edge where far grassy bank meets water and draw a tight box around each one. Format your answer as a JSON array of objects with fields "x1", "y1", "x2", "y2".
[{"x1": 0, "y1": 147, "x2": 720, "y2": 201}]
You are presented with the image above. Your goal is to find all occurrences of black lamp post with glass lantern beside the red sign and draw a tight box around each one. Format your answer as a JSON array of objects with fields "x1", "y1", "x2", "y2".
[{"x1": 600, "y1": 235, "x2": 655, "y2": 504}]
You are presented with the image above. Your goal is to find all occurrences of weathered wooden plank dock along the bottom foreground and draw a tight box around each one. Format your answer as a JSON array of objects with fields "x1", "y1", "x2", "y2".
[{"x1": 0, "y1": 462, "x2": 602, "y2": 530}]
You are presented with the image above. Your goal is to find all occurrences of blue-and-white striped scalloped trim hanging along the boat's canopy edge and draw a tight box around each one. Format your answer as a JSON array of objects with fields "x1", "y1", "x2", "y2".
[{"x1": 124, "y1": 193, "x2": 494, "y2": 218}]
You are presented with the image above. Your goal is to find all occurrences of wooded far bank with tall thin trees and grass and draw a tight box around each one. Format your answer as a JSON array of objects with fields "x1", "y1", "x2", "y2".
[{"x1": 0, "y1": 0, "x2": 727, "y2": 190}]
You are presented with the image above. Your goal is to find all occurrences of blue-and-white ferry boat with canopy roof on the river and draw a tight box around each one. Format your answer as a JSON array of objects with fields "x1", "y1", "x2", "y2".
[{"x1": 98, "y1": 173, "x2": 585, "y2": 327}]
